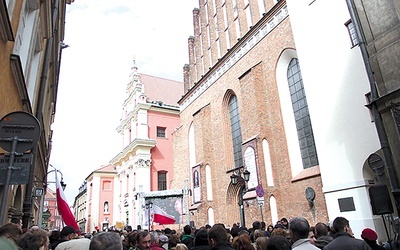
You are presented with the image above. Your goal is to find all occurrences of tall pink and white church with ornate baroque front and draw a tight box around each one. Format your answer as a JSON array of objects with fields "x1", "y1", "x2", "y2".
[{"x1": 110, "y1": 66, "x2": 183, "y2": 228}]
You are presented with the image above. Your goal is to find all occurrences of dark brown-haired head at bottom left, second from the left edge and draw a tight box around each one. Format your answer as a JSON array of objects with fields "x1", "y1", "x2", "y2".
[{"x1": 17, "y1": 229, "x2": 49, "y2": 250}]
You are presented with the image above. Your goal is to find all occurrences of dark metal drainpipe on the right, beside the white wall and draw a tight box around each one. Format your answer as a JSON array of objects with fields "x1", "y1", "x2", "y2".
[{"x1": 346, "y1": 0, "x2": 400, "y2": 215}]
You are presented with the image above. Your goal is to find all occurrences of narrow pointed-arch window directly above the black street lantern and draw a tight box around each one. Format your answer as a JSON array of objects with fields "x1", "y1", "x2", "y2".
[{"x1": 229, "y1": 95, "x2": 243, "y2": 168}]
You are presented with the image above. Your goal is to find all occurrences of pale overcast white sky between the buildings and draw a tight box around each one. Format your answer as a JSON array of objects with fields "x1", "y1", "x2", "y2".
[{"x1": 48, "y1": 0, "x2": 198, "y2": 205}]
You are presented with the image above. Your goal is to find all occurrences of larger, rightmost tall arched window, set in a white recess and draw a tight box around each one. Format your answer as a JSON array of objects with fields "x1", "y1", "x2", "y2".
[{"x1": 287, "y1": 58, "x2": 319, "y2": 169}]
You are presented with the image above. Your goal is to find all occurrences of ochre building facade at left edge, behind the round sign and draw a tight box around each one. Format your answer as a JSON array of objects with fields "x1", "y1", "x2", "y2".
[{"x1": 0, "y1": 0, "x2": 73, "y2": 227}]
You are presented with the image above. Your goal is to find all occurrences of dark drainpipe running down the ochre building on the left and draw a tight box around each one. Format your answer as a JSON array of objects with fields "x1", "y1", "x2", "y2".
[{"x1": 22, "y1": 0, "x2": 61, "y2": 228}]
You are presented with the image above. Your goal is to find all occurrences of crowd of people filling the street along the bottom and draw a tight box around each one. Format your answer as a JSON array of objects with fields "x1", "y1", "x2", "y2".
[{"x1": 0, "y1": 217, "x2": 399, "y2": 250}]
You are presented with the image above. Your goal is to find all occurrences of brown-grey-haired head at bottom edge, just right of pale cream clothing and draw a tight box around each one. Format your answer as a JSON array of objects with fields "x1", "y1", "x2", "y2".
[{"x1": 89, "y1": 232, "x2": 122, "y2": 250}]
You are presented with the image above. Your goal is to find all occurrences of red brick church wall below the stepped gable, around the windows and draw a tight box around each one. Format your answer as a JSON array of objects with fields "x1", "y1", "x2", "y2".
[{"x1": 172, "y1": 1, "x2": 327, "y2": 227}]
